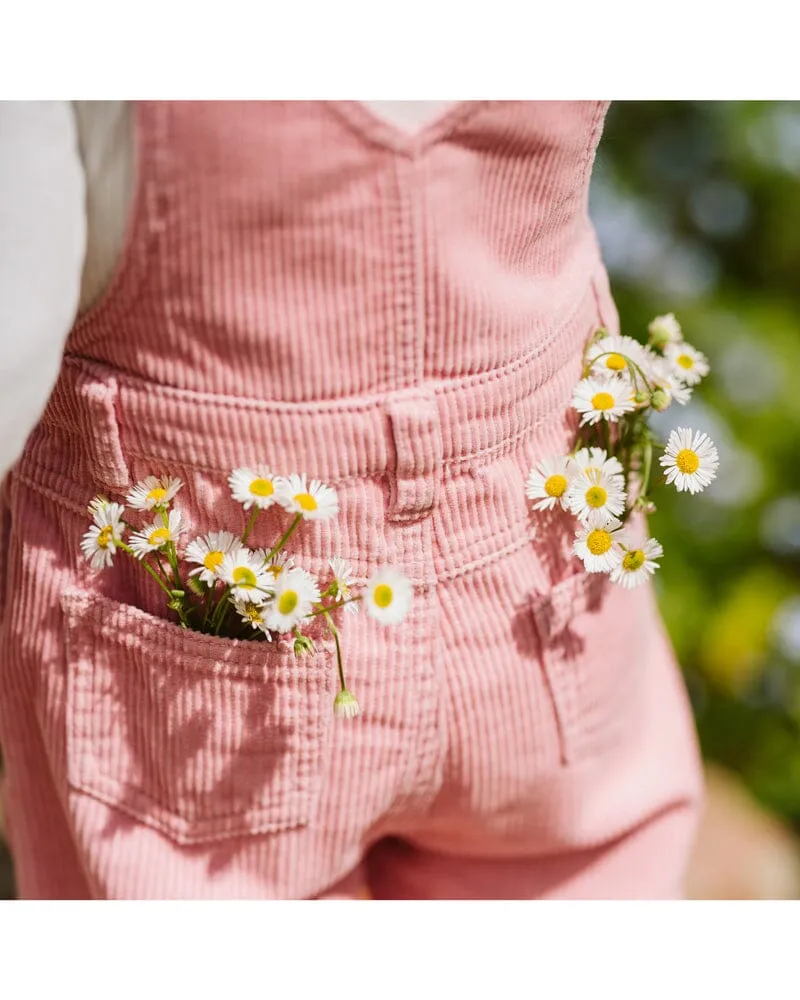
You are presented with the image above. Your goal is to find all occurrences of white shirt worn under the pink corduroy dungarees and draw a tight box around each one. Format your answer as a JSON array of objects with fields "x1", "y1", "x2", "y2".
[{"x1": 0, "y1": 101, "x2": 451, "y2": 476}]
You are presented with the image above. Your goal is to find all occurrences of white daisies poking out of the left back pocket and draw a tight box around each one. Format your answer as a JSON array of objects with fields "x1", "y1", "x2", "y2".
[{"x1": 81, "y1": 468, "x2": 412, "y2": 717}]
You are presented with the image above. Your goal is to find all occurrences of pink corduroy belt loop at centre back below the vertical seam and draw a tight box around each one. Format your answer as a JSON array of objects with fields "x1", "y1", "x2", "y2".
[{"x1": 386, "y1": 389, "x2": 442, "y2": 521}]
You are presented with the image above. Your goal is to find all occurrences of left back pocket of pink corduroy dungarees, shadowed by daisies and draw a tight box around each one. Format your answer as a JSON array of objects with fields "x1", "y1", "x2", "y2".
[{"x1": 62, "y1": 591, "x2": 335, "y2": 844}]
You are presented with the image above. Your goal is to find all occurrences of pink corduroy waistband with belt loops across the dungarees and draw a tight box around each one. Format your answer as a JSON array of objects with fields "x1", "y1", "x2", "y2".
[{"x1": 34, "y1": 286, "x2": 598, "y2": 488}]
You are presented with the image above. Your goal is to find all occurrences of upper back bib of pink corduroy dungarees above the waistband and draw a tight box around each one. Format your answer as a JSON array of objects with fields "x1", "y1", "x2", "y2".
[{"x1": 72, "y1": 102, "x2": 606, "y2": 402}]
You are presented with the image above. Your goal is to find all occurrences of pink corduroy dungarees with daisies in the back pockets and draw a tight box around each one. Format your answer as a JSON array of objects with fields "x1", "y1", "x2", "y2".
[{"x1": 0, "y1": 102, "x2": 700, "y2": 898}]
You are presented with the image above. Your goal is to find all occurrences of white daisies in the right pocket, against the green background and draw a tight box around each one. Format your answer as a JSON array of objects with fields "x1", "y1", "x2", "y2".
[{"x1": 526, "y1": 313, "x2": 719, "y2": 587}]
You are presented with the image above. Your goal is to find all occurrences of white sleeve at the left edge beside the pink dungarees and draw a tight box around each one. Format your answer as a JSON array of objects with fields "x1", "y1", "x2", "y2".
[{"x1": 0, "y1": 101, "x2": 86, "y2": 476}]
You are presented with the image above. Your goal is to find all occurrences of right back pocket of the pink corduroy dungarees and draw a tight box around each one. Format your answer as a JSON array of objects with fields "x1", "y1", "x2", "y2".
[{"x1": 531, "y1": 573, "x2": 658, "y2": 764}]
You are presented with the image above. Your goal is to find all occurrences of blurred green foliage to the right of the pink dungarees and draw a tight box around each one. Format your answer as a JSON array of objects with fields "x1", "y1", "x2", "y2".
[{"x1": 591, "y1": 102, "x2": 800, "y2": 827}]
